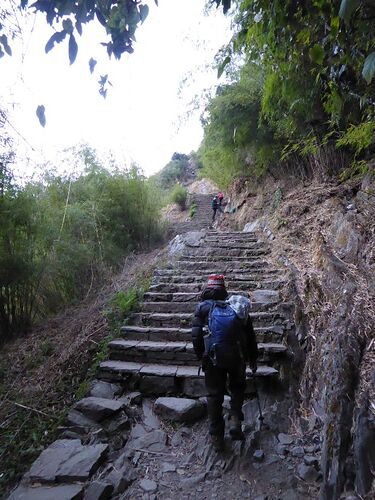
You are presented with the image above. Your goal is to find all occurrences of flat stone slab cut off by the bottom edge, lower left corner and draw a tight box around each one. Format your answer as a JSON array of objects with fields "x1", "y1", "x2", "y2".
[{"x1": 8, "y1": 484, "x2": 83, "y2": 500}]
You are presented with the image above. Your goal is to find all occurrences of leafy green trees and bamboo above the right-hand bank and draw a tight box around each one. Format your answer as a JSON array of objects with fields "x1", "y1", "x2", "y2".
[{"x1": 200, "y1": 0, "x2": 375, "y2": 185}]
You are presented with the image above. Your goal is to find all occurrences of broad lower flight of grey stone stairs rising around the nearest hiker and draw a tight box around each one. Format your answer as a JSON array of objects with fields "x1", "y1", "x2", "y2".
[{"x1": 100, "y1": 229, "x2": 292, "y2": 397}]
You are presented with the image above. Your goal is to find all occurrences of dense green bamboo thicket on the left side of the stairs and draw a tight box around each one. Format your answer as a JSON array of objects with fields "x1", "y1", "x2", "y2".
[{"x1": 0, "y1": 150, "x2": 162, "y2": 342}]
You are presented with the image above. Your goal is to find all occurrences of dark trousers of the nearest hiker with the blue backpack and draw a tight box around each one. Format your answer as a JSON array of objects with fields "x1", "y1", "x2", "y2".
[{"x1": 204, "y1": 360, "x2": 246, "y2": 436}]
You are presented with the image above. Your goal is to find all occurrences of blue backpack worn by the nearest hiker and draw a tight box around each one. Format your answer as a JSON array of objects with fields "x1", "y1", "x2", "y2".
[{"x1": 204, "y1": 301, "x2": 243, "y2": 369}]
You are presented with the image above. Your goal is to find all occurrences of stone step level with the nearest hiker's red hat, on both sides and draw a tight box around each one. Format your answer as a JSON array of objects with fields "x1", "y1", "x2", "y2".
[{"x1": 150, "y1": 278, "x2": 284, "y2": 294}]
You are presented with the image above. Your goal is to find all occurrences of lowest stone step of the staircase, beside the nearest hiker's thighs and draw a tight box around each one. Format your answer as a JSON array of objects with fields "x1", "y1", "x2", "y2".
[{"x1": 99, "y1": 360, "x2": 278, "y2": 397}]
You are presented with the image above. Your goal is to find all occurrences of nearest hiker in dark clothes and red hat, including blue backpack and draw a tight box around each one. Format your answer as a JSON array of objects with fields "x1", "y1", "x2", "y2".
[{"x1": 192, "y1": 275, "x2": 258, "y2": 451}]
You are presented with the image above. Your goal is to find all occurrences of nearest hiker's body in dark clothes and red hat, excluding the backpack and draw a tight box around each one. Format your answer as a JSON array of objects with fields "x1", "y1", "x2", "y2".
[{"x1": 192, "y1": 275, "x2": 258, "y2": 451}]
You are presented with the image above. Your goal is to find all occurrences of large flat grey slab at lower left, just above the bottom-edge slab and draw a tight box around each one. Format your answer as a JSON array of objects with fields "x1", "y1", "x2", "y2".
[{"x1": 29, "y1": 439, "x2": 108, "y2": 484}]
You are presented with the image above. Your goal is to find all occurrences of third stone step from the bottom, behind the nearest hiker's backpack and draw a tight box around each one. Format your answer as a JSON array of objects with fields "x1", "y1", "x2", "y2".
[{"x1": 120, "y1": 325, "x2": 284, "y2": 343}]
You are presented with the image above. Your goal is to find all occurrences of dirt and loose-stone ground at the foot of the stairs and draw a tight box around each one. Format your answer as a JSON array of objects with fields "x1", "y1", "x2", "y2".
[{"x1": 122, "y1": 400, "x2": 319, "y2": 500}]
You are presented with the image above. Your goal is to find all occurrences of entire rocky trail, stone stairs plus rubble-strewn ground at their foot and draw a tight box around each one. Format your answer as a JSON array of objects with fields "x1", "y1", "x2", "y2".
[{"x1": 9, "y1": 195, "x2": 321, "y2": 500}]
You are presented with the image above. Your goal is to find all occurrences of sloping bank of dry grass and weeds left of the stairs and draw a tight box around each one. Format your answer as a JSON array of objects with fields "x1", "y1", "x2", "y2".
[{"x1": 0, "y1": 249, "x2": 164, "y2": 498}]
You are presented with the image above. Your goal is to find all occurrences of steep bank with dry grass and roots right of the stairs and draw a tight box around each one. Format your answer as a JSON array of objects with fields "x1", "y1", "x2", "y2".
[{"x1": 222, "y1": 177, "x2": 375, "y2": 499}]
